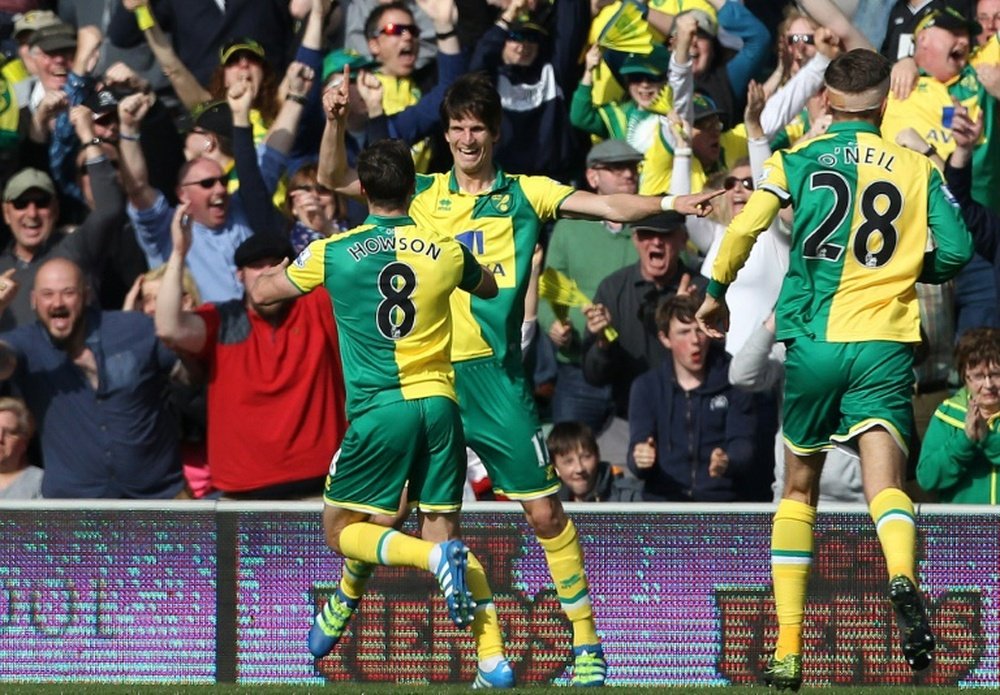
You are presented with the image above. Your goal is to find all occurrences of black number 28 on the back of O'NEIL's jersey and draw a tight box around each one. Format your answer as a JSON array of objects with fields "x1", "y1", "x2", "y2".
[{"x1": 802, "y1": 171, "x2": 903, "y2": 268}]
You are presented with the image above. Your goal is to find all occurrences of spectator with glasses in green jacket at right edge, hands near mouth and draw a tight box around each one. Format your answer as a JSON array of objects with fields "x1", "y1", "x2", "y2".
[{"x1": 917, "y1": 328, "x2": 1000, "y2": 505}]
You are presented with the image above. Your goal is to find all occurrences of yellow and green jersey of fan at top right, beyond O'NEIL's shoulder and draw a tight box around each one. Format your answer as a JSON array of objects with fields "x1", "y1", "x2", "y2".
[{"x1": 882, "y1": 65, "x2": 1000, "y2": 213}]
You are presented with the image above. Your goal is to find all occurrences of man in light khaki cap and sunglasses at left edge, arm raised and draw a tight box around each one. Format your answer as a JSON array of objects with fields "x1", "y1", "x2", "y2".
[{"x1": 0, "y1": 116, "x2": 125, "y2": 330}]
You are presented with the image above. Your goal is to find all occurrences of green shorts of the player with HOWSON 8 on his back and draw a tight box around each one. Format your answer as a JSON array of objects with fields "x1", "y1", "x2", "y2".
[{"x1": 323, "y1": 396, "x2": 466, "y2": 515}]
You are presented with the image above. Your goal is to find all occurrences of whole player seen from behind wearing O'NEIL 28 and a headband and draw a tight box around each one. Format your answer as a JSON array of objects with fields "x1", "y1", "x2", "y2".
[{"x1": 698, "y1": 49, "x2": 972, "y2": 690}]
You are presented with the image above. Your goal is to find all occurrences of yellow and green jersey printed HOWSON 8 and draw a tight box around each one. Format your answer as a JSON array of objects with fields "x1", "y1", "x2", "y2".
[{"x1": 285, "y1": 215, "x2": 482, "y2": 419}]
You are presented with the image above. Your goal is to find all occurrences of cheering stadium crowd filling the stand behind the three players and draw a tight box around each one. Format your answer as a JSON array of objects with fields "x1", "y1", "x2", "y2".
[{"x1": 0, "y1": 0, "x2": 1000, "y2": 504}]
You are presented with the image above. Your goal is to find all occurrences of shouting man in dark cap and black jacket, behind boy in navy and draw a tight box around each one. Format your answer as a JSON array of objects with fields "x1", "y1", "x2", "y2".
[{"x1": 582, "y1": 211, "x2": 703, "y2": 463}]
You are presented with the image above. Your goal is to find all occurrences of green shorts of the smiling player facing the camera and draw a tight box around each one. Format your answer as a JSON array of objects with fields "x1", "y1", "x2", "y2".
[{"x1": 455, "y1": 357, "x2": 560, "y2": 500}]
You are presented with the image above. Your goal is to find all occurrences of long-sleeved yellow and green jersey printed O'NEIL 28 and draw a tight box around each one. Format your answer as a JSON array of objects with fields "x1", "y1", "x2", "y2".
[{"x1": 708, "y1": 121, "x2": 972, "y2": 343}]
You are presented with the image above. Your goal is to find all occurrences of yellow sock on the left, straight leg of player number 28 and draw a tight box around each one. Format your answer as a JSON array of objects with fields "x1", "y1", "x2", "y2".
[{"x1": 771, "y1": 499, "x2": 816, "y2": 659}]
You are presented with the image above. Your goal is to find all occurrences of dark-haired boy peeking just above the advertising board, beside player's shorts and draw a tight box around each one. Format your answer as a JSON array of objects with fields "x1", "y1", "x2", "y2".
[{"x1": 545, "y1": 422, "x2": 641, "y2": 502}]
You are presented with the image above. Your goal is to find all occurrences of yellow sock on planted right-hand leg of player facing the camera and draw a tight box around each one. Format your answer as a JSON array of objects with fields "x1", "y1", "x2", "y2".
[{"x1": 538, "y1": 520, "x2": 601, "y2": 647}]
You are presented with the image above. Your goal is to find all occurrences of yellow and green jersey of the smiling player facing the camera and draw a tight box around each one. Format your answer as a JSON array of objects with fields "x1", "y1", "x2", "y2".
[{"x1": 410, "y1": 168, "x2": 575, "y2": 369}]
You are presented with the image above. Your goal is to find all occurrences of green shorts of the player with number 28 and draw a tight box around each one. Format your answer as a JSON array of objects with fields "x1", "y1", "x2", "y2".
[{"x1": 783, "y1": 338, "x2": 913, "y2": 456}]
